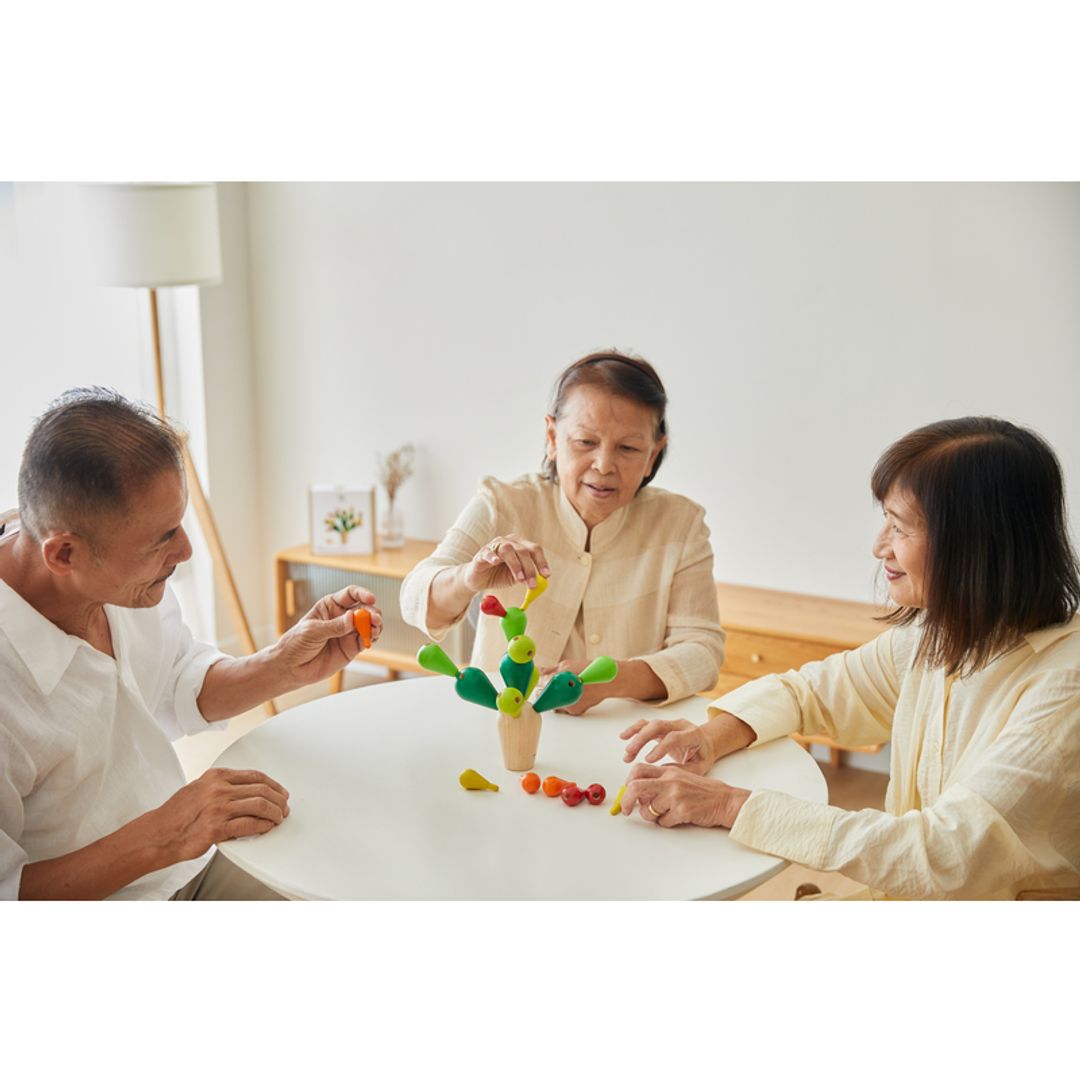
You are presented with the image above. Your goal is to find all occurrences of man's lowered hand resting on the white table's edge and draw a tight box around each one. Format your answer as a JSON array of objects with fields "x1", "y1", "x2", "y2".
[{"x1": 150, "y1": 769, "x2": 288, "y2": 865}]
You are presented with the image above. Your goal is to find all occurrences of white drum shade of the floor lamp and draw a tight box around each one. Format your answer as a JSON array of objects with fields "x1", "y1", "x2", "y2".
[{"x1": 85, "y1": 184, "x2": 221, "y2": 288}]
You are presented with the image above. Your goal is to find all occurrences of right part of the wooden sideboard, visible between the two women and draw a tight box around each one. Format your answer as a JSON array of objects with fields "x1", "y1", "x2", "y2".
[{"x1": 710, "y1": 582, "x2": 887, "y2": 765}]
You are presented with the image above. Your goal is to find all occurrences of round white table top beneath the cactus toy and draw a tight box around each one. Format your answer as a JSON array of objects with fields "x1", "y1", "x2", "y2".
[{"x1": 216, "y1": 677, "x2": 827, "y2": 900}]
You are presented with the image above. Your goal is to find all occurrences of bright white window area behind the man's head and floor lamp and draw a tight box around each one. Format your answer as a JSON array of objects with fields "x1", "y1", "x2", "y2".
[{"x1": 0, "y1": 184, "x2": 216, "y2": 639}]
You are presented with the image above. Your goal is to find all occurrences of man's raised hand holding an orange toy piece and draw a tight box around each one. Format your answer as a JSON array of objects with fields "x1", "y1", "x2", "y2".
[{"x1": 271, "y1": 585, "x2": 382, "y2": 687}]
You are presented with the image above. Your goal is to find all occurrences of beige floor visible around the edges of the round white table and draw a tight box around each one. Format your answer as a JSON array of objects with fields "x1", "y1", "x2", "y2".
[{"x1": 175, "y1": 671, "x2": 888, "y2": 900}]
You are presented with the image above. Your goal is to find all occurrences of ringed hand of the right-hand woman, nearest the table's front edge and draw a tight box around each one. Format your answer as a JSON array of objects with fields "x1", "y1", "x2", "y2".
[{"x1": 622, "y1": 765, "x2": 751, "y2": 828}]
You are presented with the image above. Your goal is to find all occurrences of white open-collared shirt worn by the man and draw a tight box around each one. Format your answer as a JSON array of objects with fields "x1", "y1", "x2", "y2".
[{"x1": 0, "y1": 581, "x2": 227, "y2": 900}]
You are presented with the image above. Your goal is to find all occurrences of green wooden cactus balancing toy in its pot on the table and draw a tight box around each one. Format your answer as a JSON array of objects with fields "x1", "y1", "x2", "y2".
[{"x1": 416, "y1": 573, "x2": 619, "y2": 772}]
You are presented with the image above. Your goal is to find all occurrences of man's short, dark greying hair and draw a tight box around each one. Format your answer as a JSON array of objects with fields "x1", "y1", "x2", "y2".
[{"x1": 18, "y1": 387, "x2": 184, "y2": 542}]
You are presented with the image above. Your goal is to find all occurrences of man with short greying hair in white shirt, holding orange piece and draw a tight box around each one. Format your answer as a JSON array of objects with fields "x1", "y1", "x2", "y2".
[{"x1": 0, "y1": 389, "x2": 381, "y2": 900}]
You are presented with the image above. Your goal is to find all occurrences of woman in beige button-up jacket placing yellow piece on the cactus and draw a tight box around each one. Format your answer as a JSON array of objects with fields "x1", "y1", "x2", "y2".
[{"x1": 401, "y1": 352, "x2": 724, "y2": 713}]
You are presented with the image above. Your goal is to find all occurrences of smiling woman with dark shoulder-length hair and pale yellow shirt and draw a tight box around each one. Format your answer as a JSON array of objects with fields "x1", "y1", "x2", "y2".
[{"x1": 622, "y1": 417, "x2": 1080, "y2": 899}]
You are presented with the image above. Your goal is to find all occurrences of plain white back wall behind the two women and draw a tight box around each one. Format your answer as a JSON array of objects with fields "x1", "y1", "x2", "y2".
[{"x1": 238, "y1": 184, "x2": 1080, "y2": 622}]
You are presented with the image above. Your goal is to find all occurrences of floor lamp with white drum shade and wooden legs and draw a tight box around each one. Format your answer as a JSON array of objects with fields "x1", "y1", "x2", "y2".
[{"x1": 87, "y1": 184, "x2": 278, "y2": 716}]
